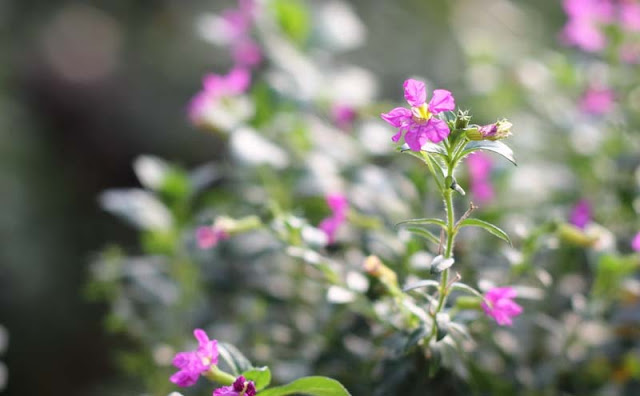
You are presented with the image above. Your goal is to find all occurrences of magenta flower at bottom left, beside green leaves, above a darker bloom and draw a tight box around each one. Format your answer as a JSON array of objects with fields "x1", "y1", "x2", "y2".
[{"x1": 169, "y1": 329, "x2": 218, "y2": 387}]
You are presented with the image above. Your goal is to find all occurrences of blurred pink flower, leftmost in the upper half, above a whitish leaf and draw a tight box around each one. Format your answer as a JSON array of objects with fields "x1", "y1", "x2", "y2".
[{"x1": 188, "y1": 67, "x2": 251, "y2": 125}]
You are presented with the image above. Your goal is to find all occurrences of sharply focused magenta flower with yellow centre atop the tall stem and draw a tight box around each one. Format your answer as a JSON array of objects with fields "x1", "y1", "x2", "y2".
[{"x1": 380, "y1": 79, "x2": 456, "y2": 151}]
